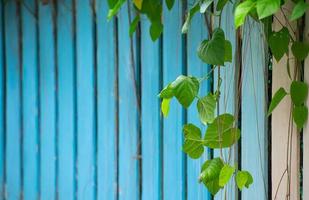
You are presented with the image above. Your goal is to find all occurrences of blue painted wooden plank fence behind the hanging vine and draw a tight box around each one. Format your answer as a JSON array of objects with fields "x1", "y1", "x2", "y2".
[{"x1": 0, "y1": 0, "x2": 269, "y2": 200}]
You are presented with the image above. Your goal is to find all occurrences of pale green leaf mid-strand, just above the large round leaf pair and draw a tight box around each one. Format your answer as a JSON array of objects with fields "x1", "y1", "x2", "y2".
[{"x1": 197, "y1": 93, "x2": 216, "y2": 125}]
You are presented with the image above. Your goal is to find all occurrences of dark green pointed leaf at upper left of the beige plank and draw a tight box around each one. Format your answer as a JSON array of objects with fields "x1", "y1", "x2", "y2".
[{"x1": 268, "y1": 27, "x2": 290, "y2": 61}]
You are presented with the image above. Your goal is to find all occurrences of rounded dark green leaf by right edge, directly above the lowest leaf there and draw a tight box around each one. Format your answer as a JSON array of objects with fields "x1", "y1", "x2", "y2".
[{"x1": 290, "y1": 81, "x2": 308, "y2": 106}]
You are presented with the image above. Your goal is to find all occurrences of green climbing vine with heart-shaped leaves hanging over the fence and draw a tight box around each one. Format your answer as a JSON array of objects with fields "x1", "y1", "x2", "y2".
[{"x1": 107, "y1": 0, "x2": 309, "y2": 198}]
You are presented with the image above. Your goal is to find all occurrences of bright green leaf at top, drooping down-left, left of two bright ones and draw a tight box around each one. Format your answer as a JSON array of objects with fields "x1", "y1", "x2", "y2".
[{"x1": 234, "y1": 0, "x2": 255, "y2": 29}]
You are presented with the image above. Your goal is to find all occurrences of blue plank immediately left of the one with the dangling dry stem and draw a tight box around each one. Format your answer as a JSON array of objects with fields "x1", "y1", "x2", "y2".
[{"x1": 96, "y1": 1, "x2": 118, "y2": 200}]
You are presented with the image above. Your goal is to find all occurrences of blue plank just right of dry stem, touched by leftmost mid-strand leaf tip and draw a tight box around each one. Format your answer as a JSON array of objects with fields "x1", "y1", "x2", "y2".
[{"x1": 141, "y1": 18, "x2": 163, "y2": 200}]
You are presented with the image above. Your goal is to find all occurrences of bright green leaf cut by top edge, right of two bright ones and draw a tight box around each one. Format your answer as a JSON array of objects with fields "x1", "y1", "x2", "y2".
[{"x1": 256, "y1": 0, "x2": 281, "y2": 19}]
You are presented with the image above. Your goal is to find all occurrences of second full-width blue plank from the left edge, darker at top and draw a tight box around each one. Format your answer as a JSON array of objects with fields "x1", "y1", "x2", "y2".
[{"x1": 22, "y1": 0, "x2": 39, "y2": 200}]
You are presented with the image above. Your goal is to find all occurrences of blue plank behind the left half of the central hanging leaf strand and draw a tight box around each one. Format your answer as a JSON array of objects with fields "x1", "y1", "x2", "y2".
[{"x1": 187, "y1": 0, "x2": 211, "y2": 200}]
